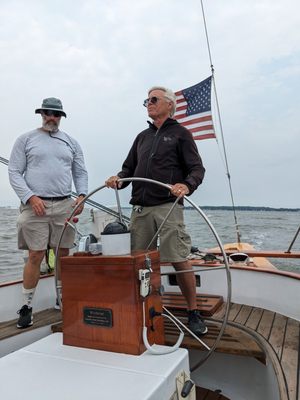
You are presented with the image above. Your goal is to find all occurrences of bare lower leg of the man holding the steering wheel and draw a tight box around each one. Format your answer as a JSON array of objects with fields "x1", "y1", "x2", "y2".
[{"x1": 173, "y1": 261, "x2": 197, "y2": 310}]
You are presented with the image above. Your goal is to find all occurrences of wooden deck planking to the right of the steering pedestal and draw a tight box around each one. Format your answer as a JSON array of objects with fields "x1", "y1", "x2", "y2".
[{"x1": 165, "y1": 293, "x2": 300, "y2": 400}]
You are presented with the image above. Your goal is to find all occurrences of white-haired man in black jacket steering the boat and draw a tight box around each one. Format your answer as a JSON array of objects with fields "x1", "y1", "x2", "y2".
[{"x1": 105, "y1": 86, "x2": 207, "y2": 336}]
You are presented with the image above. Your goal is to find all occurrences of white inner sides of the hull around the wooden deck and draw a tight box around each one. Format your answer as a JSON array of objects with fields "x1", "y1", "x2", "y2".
[{"x1": 0, "y1": 266, "x2": 300, "y2": 322}]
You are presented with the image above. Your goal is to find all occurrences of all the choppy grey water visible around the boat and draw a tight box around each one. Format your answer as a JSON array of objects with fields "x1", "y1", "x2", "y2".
[{"x1": 0, "y1": 207, "x2": 300, "y2": 282}]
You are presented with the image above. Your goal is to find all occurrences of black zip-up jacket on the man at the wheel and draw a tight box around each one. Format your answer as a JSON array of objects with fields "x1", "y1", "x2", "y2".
[{"x1": 118, "y1": 118, "x2": 205, "y2": 206}]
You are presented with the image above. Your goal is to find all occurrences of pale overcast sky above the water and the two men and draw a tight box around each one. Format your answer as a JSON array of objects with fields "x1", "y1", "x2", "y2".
[{"x1": 0, "y1": 0, "x2": 300, "y2": 208}]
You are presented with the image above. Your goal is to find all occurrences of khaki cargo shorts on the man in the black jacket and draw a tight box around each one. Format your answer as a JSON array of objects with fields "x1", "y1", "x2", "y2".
[{"x1": 130, "y1": 203, "x2": 191, "y2": 263}]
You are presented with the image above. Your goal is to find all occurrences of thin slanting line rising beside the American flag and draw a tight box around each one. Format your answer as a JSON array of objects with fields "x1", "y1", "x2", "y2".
[{"x1": 200, "y1": 0, "x2": 241, "y2": 243}]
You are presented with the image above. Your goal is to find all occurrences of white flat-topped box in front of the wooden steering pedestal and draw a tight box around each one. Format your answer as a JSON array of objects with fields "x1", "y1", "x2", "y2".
[{"x1": 0, "y1": 333, "x2": 189, "y2": 400}]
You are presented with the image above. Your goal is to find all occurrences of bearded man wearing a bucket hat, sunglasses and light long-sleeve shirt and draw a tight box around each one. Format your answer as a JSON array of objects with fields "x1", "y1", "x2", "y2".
[{"x1": 8, "y1": 97, "x2": 88, "y2": 328}]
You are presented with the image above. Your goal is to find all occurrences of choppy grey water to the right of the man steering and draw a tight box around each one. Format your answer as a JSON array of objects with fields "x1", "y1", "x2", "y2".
[{"x1": 186, "y1": 206, "x2": 300, "y2": 273}]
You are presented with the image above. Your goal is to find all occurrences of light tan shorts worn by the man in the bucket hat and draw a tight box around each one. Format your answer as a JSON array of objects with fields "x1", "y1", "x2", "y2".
[{"x1": 17, "y1": 198, "x2": 75, "y2": 251}]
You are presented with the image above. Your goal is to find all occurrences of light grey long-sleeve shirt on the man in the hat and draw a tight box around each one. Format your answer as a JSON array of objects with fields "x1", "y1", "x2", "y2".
[{"x1": 8, "y1": 129, "x2": 88, "y2": 204}]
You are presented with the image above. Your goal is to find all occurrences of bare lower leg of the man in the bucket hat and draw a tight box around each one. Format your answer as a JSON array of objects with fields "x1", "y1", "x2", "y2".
[{"x1": 23, "y1": 250, "x2": 45, "y2": 289}]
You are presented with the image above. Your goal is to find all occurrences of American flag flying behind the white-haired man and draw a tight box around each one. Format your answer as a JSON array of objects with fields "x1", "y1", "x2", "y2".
[{"x1": 174, "y1": 76, "x2": 216, "y2": 140}]
